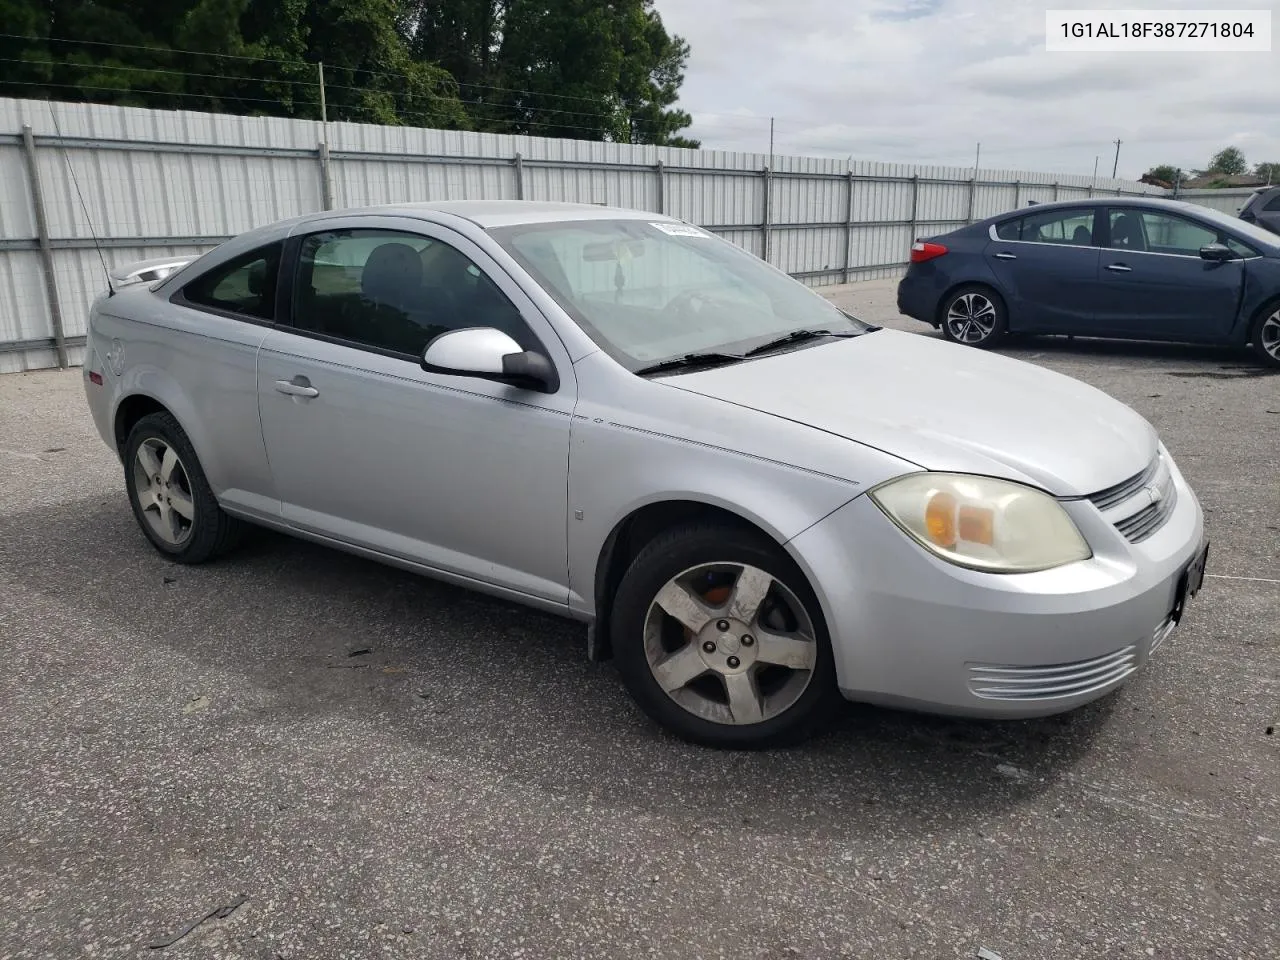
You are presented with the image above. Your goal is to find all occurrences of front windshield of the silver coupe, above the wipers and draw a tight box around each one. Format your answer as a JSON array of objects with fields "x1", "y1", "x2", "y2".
[{"x1": 490, "y1": 220, "x2": 870, "y2": 370}]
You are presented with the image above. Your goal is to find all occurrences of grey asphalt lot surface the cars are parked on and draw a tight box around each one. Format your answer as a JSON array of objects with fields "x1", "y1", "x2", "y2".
[{"x1": 0, "y1": 282, "x2": 1280, "y2": 960}]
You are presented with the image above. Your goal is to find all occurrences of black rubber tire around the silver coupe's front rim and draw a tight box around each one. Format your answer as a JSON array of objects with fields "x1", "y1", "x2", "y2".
[{"x1": 611, "y1": 524, "x2": 841, "y2": 749}]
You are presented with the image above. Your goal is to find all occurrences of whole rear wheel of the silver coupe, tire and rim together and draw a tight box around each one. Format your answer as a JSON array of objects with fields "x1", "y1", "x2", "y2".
[{"x1": 124, "y1": 413, "x2": 243, "y2": 563}]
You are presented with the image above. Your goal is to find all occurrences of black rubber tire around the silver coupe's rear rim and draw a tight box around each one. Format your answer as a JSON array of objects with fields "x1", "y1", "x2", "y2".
[{"x1": 124, "y1": 413, "x2": 244, "y2": 563}]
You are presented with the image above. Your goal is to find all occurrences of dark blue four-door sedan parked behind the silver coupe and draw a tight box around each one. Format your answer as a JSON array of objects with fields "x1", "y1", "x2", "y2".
[{"x1": 897, "y1": 198, "x2": 1280, "y2": 366}]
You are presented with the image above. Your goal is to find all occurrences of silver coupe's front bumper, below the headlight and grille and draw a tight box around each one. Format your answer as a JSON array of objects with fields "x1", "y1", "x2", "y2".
[{"x1": 788, "y1": 465, "x2": 1204, "y2": 717}]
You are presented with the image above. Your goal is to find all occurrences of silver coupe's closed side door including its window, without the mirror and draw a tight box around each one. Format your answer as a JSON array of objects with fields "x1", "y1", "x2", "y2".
[{"x1": 257, "y1": 216, "x2": 576, "y2": 605}]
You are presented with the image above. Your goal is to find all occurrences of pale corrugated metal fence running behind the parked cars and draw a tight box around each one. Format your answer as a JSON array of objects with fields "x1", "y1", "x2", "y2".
[{"x1": 0, "y1": 99, "x2": 1164, "y2": 372}]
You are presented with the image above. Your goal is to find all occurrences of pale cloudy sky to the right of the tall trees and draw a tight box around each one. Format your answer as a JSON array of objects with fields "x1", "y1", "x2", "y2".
[{"x1": 655, "y1": 0, "x2": 1280, "y2": 178}]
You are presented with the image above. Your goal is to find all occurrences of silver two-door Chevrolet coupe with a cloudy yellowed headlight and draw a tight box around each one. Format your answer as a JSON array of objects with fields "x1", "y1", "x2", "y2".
[{"x1": 84, "y1": 202, "x2": 1207, "y2": 746}]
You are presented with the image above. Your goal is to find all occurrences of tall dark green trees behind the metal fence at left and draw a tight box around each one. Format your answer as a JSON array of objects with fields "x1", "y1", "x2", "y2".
[{"x1": 0, "y1": 0, "x2": 698, "y2": 146}]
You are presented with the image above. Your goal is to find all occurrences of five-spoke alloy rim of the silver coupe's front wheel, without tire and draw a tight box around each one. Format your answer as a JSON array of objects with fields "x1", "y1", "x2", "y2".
[{"x1": 644, "y1": 563, "x2": 818, "y2": 726}]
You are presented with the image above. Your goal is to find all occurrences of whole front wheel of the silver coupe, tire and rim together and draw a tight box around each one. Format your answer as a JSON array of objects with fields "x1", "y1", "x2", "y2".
[{"x1": 611, "y1": 525, "x2": 840, "y2": 749}]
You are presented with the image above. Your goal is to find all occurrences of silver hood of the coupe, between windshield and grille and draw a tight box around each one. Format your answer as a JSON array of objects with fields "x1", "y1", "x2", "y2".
[{"x1": 659, "y1": 330, "x2": 1158, "y2": 497}]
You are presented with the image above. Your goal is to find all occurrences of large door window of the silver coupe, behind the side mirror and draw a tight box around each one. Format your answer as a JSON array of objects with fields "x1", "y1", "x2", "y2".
[{"x1": 293, "y1": 229, "x2": 538, "y2": 356}]
